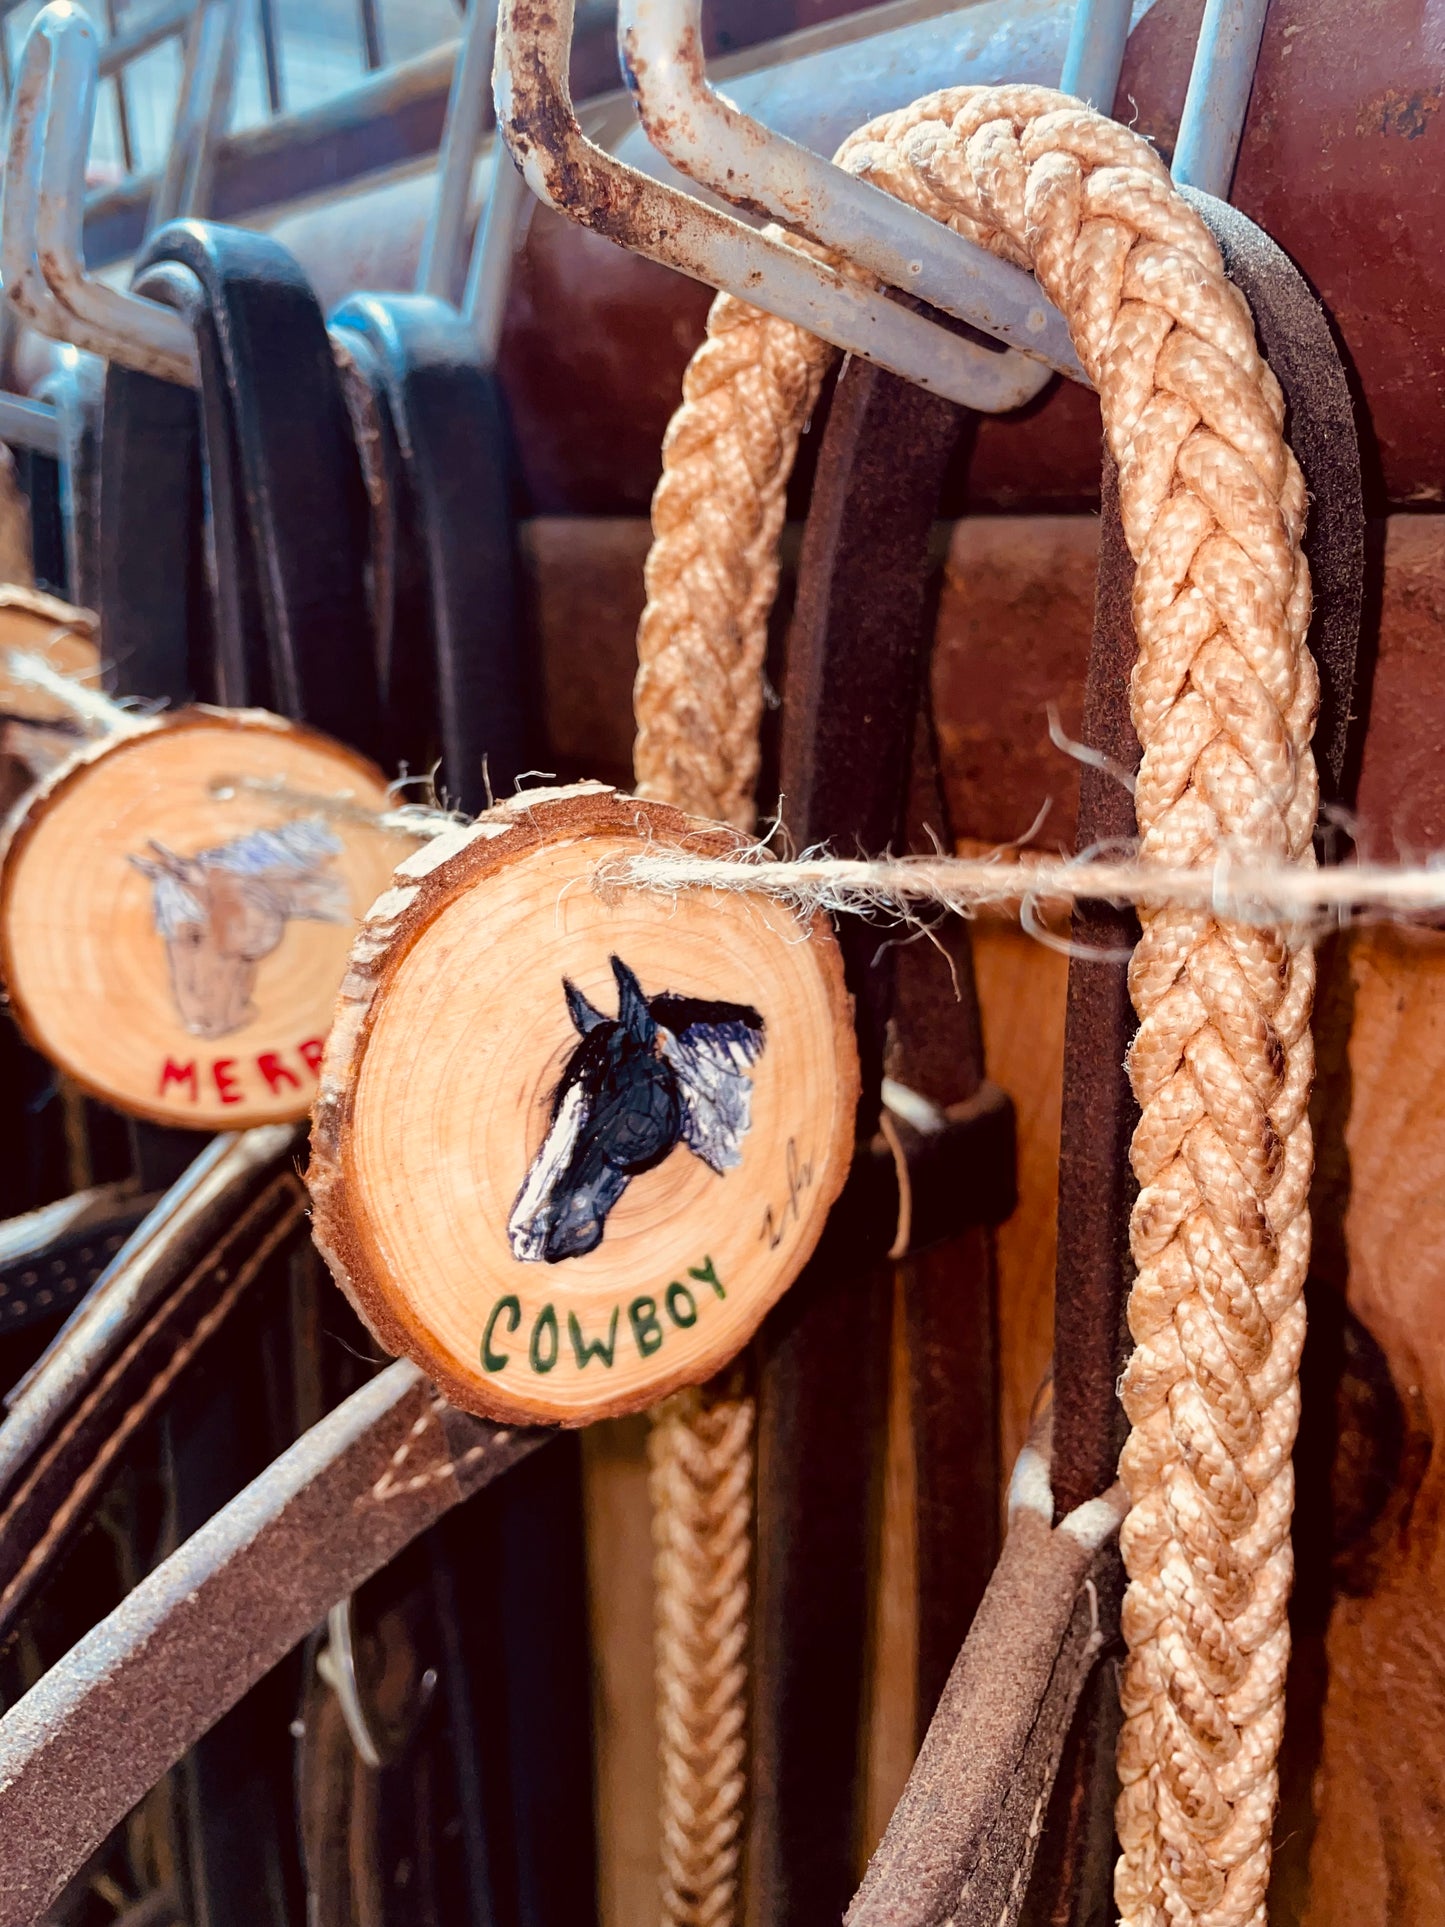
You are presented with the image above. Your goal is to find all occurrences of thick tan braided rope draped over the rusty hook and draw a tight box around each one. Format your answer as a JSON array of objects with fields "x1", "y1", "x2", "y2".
[{"x1": 636, "y1": 87, "x2": 1318, "y2": 1927}]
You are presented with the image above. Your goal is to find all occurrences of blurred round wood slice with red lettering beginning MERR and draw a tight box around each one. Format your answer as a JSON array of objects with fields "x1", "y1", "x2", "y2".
[{"x1": 0, "y1": 707, "x2": 414, "y2": 1129}]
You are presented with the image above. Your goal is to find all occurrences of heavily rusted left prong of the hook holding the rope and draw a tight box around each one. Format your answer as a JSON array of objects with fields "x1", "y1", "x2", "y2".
[{"x1": 495, "y1": 0, "x2": 1063, "y2": 412}]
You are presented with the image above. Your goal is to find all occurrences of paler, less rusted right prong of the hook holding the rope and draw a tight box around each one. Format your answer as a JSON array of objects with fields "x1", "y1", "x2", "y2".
[{"x1": 618, "y1": 0, "x2": 1087, "y2": 391}]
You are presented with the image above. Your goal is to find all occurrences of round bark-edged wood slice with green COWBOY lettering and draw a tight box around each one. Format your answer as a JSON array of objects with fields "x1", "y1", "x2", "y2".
[{"x1": 308, "y1": 784, "x2": 857, "y2": 1426}]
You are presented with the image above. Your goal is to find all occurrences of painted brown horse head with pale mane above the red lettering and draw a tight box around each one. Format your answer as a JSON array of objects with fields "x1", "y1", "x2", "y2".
[{"x1": 131, "y1": 817, "x2": 351, "y2": 1037}]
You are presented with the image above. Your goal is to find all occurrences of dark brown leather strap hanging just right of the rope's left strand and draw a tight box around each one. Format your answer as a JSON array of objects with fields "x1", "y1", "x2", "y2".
[{"x1": 748, "y1": 362, "x2": 1012, "y2": 1927}]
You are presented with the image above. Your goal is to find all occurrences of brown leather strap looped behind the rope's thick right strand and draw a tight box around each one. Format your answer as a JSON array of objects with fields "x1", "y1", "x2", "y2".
[{"x1": 848, "y1": 195, "x2": 1364, "y2": 1927}]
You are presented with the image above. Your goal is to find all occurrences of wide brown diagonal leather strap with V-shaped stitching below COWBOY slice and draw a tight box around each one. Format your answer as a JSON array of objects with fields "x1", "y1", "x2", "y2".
[{"x1": 0, "y1": 1360, "x2": 551, "y2": 1927}]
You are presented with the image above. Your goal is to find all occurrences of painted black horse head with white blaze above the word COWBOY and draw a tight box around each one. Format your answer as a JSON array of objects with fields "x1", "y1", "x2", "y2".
[{"x1": 507, "y1": 958, "x2": 763, "y2": 1264}]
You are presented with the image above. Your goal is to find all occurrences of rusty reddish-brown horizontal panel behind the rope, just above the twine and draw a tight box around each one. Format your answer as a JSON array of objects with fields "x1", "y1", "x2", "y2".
[{"x1": 524, "y1": 504, "x2": 1445, "y2": 856}]
